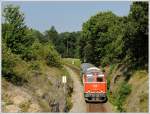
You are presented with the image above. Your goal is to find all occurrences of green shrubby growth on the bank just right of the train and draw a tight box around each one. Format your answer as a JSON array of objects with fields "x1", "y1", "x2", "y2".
[{"x1": 107, "y1": 64, "x2": 131, "y2": 112}]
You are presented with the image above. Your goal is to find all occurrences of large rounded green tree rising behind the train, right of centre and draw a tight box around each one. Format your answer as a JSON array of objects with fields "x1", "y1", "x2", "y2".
[{"x1": 80, "y1": 12, "x2": 123, "y2": 66}]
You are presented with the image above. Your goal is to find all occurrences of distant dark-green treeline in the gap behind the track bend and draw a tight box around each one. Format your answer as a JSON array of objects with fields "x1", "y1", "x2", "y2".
[{"x1": 41, "y1": 26, "x2": 81, "y2": 58}]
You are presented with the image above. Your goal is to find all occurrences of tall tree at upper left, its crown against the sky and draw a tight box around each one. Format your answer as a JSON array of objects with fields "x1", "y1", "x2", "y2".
[{"x1": 2, "y1": 5, "x2": 33, "y2": 54}]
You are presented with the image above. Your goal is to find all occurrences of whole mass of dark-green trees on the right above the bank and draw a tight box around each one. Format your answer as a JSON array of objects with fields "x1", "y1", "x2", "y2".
[{"x1": 79, "y1": 2, "x2": 148, "y2": 68}]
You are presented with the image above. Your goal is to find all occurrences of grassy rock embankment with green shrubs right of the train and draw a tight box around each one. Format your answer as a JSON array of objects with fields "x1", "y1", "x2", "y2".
[{"x1": 107, "y1": 64, "x2": 148, "y2": 112}]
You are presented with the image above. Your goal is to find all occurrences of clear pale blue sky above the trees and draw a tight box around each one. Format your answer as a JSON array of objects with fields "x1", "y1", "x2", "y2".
[{"x1": 2, "y1": 1, "x2": 132, "y2": 33}]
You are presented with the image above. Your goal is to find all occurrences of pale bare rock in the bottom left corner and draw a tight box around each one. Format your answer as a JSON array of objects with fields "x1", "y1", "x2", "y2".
[{"x1": 2, "y1": 80, "x2": 41, "y2": 112}]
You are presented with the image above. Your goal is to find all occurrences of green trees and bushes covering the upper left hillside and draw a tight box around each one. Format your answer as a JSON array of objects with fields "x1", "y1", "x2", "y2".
[{"x1": 2, "y1": 5, "x2": 61, "y2": 85}]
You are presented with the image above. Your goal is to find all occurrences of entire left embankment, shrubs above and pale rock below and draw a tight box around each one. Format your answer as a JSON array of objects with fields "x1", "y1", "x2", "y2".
[{"x1": 2, "y1": 45, "x2": 73, "y2": 112}]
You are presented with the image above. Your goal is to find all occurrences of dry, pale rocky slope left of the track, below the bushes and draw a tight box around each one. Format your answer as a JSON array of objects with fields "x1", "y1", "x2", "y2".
[{"x1": 2, "y1": 67, "x2": 72, "y2": 112}]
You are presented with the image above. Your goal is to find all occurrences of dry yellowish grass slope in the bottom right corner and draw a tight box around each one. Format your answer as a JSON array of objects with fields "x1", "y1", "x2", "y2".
[{"x1": 125, "y1": 70, "x2": 148, "y2": 112}]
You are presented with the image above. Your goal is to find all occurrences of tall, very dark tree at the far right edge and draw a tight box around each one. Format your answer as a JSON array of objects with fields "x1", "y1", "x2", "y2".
[{"x1": 124, "y1": 2, "x2": 148, "y2": 66}]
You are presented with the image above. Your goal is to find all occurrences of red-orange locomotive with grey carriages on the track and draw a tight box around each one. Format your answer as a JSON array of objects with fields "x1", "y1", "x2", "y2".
[{"x1": 81, "y1": 63, "x2": 107, "y2": 103}]
